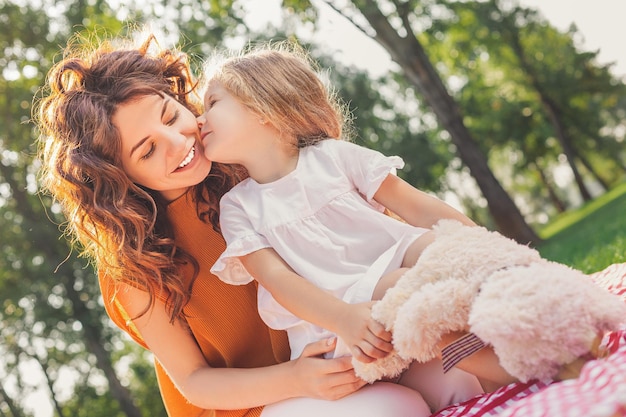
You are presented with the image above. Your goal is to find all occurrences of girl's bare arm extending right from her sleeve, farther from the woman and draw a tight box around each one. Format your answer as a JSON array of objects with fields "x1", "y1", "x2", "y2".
[{"x1": 374, "y1": 174, "x2": 476, "y2": 229}]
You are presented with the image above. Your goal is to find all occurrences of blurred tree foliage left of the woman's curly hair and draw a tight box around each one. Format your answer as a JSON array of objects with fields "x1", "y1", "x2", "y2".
[{"x1": 0, "y1": 0, "x2": 219, "y2": 416}]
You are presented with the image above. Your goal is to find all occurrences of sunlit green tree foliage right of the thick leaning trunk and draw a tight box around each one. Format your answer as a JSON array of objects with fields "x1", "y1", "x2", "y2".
[{"x1": 429, "y1": 0, "x2": 624, "y2": 215}]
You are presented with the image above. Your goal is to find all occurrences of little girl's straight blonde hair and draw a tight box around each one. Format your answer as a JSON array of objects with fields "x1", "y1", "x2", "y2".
[{"x1": 204, "y1": 41, "x2": 349, "y2": 148}]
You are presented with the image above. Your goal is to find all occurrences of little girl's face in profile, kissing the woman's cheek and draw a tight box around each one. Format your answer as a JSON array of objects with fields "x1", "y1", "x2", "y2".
[{"x1": 198, "y1": 82, "x2": 267, "y2": 166}]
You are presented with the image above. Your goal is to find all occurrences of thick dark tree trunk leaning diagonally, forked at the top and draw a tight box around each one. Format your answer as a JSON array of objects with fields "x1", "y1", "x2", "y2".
[{"x1": 284, "y1": 0, "x2": 539, "y2": 243}]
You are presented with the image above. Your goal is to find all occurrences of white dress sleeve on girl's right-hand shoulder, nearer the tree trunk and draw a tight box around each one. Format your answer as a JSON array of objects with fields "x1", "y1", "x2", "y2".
[{"x1": 321, "y1": 139, "x2": 404, "y2": 206}]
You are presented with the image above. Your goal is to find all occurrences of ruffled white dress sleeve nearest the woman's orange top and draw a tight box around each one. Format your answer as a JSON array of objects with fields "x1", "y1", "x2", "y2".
[{"x1": 211, "y1": 188, "x2": 271, "y2": 285}]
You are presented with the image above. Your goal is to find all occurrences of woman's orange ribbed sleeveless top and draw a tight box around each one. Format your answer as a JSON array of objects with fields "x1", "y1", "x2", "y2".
[{"x1": 99, "y1": 193, "x2": 289, "y2": 417}]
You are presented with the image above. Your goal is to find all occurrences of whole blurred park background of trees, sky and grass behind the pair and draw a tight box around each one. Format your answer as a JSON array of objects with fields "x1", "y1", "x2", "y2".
[{"x1": 0, "y1": 0, "x2": 626, "y2": 417}]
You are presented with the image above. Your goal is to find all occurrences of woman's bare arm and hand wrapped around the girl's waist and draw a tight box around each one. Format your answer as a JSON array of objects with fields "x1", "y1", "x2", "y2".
[{"x1": 117, "y1": 285, "x2": 363, "y2": 410}]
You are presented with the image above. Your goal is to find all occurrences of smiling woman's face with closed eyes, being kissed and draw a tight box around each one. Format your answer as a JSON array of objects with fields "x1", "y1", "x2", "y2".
[{"x1": 112, "y1": 95, "x2": 211, "y2": 201}]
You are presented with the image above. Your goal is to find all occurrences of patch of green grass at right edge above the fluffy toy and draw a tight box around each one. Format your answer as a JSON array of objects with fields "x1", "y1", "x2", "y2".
[{"x1": 537, "y1": 183, "x2": 626, "y2": 273}]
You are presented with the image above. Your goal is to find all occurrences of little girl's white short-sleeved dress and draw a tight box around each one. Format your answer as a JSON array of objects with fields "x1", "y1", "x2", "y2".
[{"x1": 211, "y1": 139, "x2": 426, "y2": 358}]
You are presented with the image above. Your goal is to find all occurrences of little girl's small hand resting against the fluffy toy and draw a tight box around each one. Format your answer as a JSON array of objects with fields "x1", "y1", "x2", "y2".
[{"x1": 336, "y1": 302, "x2": 393, "y2": 362}]
